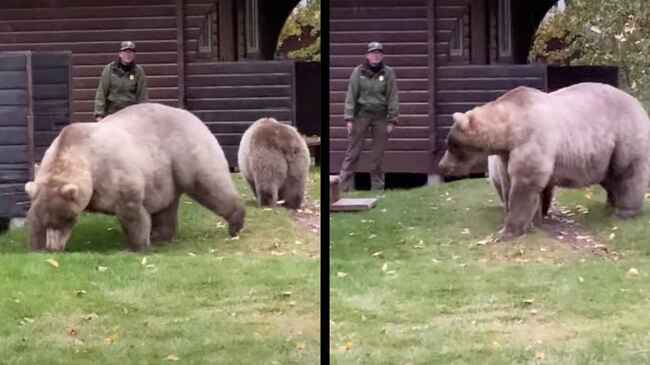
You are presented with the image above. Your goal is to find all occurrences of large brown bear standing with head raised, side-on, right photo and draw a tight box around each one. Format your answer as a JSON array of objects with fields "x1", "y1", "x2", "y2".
[{"x1": 439, "y1": 83, "x2": 650, "y2": 239}]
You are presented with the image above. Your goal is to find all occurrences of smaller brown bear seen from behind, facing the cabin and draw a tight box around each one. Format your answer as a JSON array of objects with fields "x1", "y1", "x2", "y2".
[{"x1": 238, "y1": 118, "x2": 310, "y2": 209}]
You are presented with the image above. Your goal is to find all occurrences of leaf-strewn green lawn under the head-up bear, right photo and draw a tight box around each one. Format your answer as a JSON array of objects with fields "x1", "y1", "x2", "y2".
[{"x1": 330, "y1": 179, "x2": 650, "y2": 364}]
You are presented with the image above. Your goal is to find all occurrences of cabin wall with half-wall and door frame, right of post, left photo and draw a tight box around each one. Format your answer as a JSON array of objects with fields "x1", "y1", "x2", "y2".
[{"x1": 184, "y1": 0, "x2": 298, "y2": 166}]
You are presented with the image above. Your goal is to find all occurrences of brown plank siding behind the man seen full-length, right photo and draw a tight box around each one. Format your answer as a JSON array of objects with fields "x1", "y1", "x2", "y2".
[{"x1": 329, "y1": 0, "x2": 433, "y2": 173}]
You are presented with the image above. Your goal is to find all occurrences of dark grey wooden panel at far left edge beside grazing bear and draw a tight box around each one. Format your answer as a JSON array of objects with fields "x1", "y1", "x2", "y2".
[{"x1": 0, "y1": 52, "x2": 70, "y2": 217}]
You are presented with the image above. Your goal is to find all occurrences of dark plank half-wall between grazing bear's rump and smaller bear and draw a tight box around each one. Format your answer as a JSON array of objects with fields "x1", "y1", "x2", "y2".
[{"x1": 185, "y1": 61, "x2": 295, "y2": 166}]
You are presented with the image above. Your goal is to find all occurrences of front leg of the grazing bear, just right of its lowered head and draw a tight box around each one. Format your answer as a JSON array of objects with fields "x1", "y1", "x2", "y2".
[{"x1": 116, "y1": 203, "x2": 151, "y2": 251}]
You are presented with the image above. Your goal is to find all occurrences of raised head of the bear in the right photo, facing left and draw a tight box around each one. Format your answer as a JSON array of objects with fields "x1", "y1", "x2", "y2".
[{"x1": 438, "y1": 111, "x2": 488, "y2": 176}]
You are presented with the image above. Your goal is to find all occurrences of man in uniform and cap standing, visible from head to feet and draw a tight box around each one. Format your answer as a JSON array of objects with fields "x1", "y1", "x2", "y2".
[{"x1": 339, "y1": 42, "x2": 399, "y2": 192}]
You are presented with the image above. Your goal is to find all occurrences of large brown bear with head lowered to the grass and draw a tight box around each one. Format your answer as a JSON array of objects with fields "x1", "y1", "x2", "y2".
[{"x1": 25, "y1": 103, "x2": 245, "y2": 251}]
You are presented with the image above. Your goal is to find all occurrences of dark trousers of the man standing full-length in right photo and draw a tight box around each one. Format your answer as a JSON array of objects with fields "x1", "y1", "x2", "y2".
[{"x1": 339, "y1": 117, "x2": 388, "y2": 191}]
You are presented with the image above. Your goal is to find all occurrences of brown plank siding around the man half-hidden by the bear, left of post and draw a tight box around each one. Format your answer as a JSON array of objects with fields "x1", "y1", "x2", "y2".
[{"x1": 0, "y1": 0, "x2": 178, "y2": 122}]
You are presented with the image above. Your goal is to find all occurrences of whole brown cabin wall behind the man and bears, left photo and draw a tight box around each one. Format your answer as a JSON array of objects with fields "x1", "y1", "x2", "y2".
[{"x1": 0, "y1": 0, "x2": 306, "y2": 166}]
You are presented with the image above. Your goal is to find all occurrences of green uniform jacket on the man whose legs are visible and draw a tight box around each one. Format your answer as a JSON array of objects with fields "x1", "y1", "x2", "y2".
[{"x1": 343, "y1": 63, "x2": 399, "y2": 123}]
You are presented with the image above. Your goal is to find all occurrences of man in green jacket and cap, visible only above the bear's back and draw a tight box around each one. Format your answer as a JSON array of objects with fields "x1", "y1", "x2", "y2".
[{"x1": 95, "y1": 41, "x2": 148, "y2": 122}]
